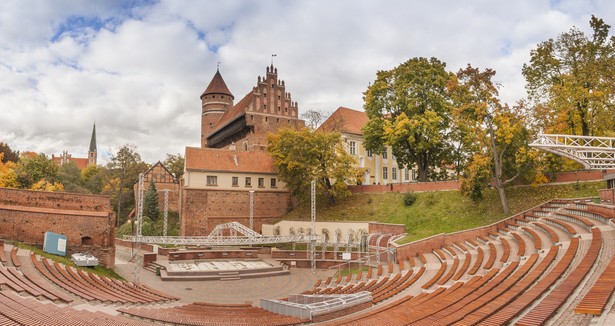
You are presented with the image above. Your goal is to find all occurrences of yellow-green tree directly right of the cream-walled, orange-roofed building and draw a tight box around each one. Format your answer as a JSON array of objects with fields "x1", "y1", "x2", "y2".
[{"x1": 267, "y1": 128, "x2": 358, "y2": 204}]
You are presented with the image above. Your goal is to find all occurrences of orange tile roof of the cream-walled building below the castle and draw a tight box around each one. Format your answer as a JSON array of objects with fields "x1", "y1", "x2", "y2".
[{"x1": 185, "y1": 147, "x2": 276, "y2": 173}]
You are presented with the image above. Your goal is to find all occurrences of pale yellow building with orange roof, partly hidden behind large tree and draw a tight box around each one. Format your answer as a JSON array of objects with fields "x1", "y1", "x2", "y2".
[{"x1": 318, "y1": 107, "x2": 454, "y2": 185}]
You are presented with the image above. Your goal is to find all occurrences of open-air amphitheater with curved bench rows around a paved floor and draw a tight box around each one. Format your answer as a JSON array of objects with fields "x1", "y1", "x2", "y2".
[{"x1": 0, "y1": 199, "x2": 615, "y2": 325}]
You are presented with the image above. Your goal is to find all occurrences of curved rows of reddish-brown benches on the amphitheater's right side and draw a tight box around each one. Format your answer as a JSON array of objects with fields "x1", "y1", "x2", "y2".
[{"x1": 328, "y1": 200, "x2": 615, "y2": 325}]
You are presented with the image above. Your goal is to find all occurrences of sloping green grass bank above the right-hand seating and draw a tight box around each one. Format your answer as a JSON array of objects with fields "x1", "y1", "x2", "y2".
[{"x1": 282, "y1": 181, "x2": 605, "y2": 242}]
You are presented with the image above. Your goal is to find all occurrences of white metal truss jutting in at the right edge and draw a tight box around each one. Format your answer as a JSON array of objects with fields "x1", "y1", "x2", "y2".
[{"x1": 530, "y1": 134, "x2": 615, "y2": 170}]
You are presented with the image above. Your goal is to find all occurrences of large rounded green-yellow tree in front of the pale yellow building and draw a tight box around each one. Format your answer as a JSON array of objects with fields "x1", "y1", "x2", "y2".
[{"x1": 363, "y1": 58, "x2": 454, "y2": 181}]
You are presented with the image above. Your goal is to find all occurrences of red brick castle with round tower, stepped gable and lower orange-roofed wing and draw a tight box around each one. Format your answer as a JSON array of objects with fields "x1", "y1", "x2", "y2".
[{"x1": 180, "y1": 65, "x2": 305, "y2": 236}]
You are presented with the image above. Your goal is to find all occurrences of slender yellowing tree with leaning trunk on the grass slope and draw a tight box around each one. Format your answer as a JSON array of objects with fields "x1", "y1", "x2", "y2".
[{"x1": 449, "y1": 65, "x2": 529, "y2": 213}]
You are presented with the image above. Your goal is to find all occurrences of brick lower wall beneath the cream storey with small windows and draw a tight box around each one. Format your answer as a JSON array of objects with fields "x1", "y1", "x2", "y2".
[{"x1": 180, "y1": 188, "x2": 290, "y2": 236}]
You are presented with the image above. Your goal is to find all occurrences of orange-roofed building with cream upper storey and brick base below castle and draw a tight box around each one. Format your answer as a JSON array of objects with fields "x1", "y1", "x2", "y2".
[{"x1": 180, "y1": 147, "x2": 290, "y2": 236}]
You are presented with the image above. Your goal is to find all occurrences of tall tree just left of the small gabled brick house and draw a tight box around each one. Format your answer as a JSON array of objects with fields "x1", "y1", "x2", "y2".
[{"x1": 103, "y1": 145, "x2": 148, "y2": 226}]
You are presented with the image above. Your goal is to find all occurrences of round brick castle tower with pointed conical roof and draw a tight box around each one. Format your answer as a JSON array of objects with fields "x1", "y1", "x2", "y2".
[{"x1": 201, "y1": 69, "x2": 235, "y2": 148}]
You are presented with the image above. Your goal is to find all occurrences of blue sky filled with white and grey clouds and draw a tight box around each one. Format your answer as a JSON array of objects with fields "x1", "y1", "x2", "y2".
[{"x1": 0, "y1": 0, "x2": 615, "y2": 164}]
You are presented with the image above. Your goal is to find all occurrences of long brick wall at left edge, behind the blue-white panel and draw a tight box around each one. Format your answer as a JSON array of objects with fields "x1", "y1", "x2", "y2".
[{"x1": 0, "y1": 188, "x2": 115, "y2": 267}]
